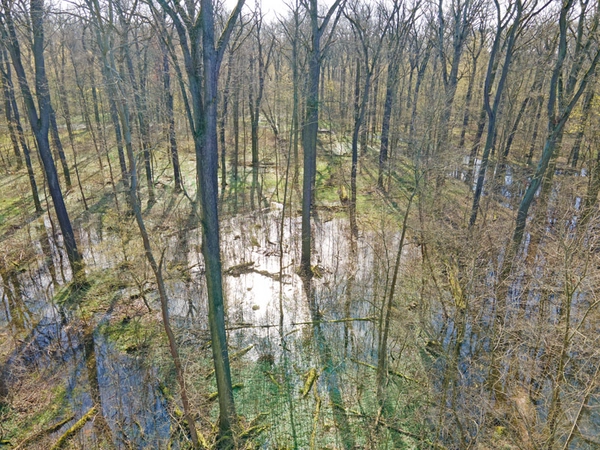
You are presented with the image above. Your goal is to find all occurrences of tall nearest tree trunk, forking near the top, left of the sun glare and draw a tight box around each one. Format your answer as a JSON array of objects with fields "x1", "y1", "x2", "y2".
[{"x1": 159, "y1": 0, "x2": 244, "y2": 446}]
